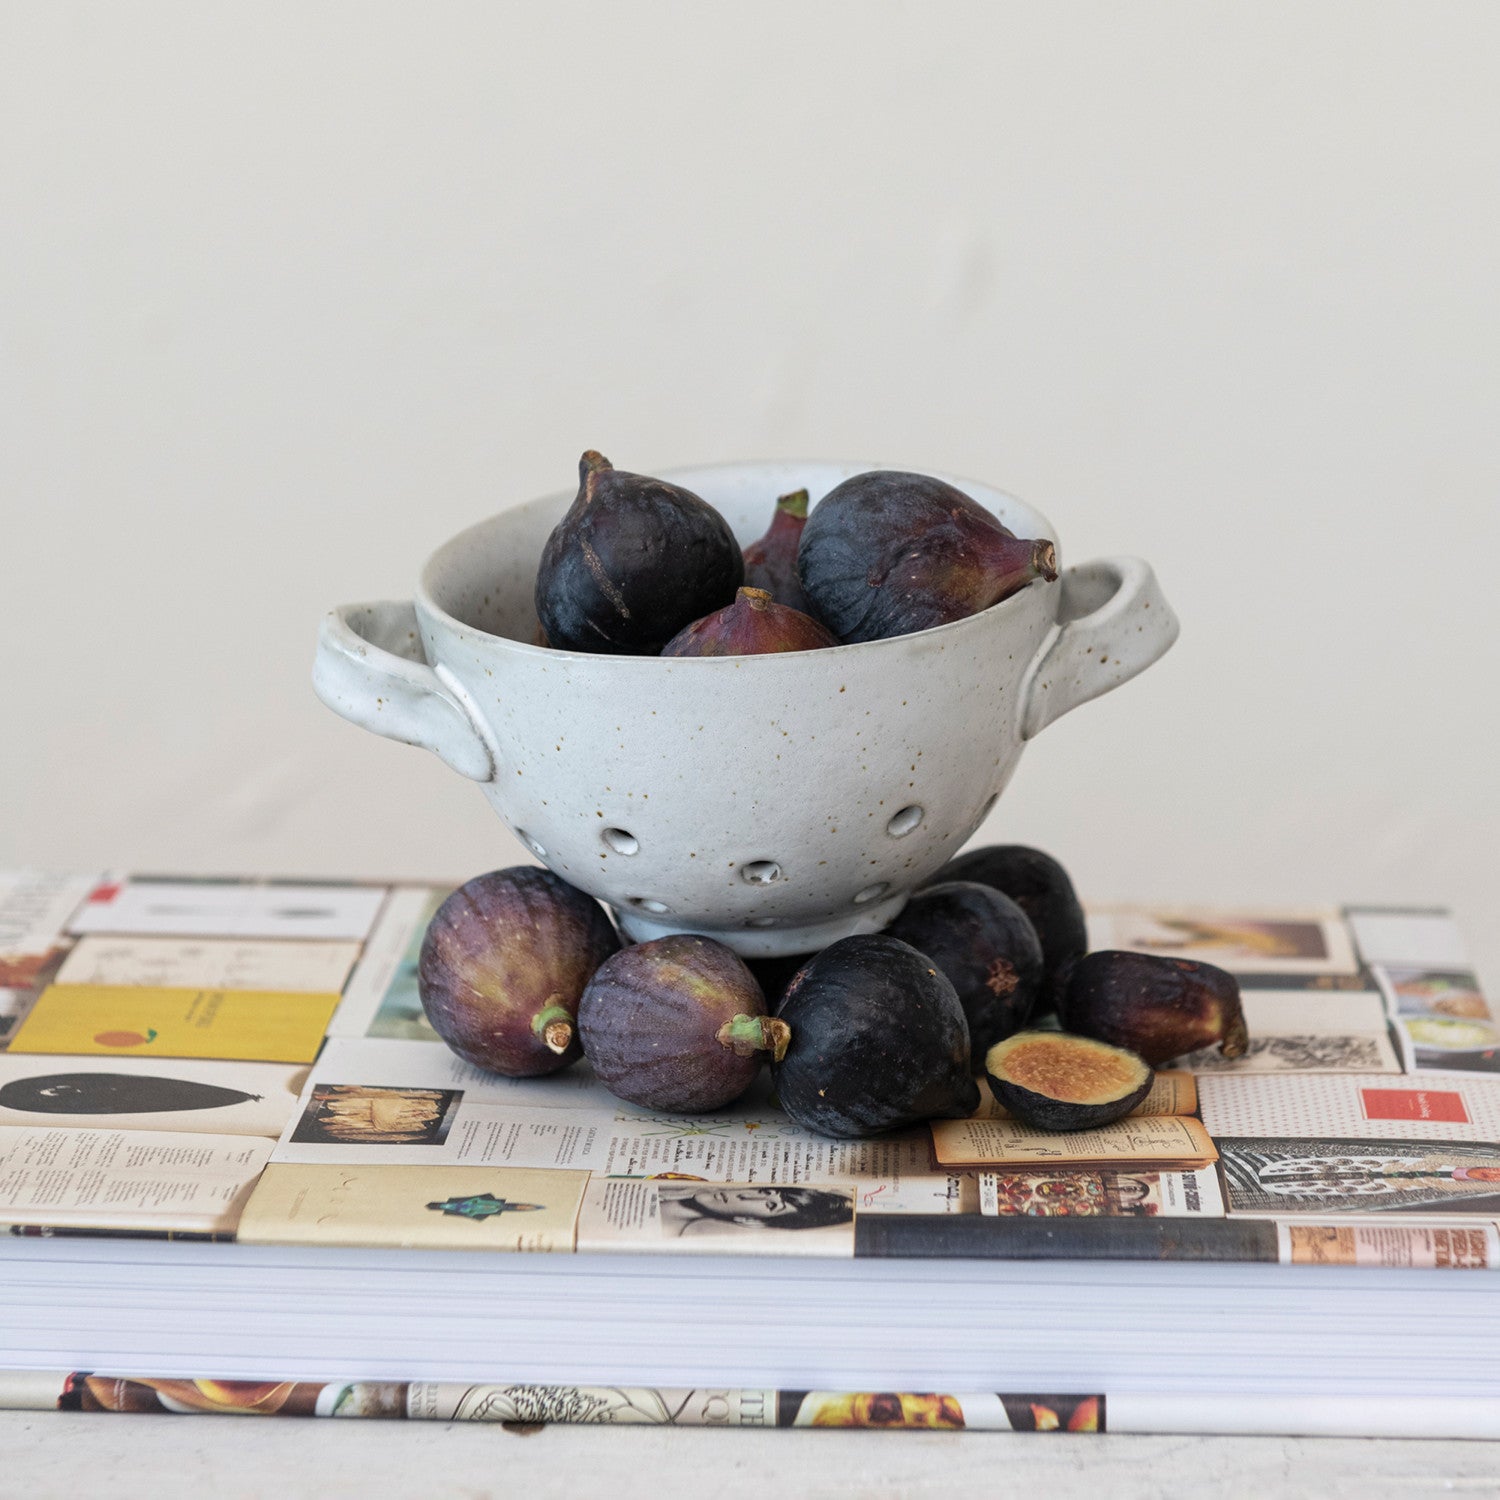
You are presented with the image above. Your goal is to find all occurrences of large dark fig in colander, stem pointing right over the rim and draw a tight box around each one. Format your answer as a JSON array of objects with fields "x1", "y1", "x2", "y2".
[{"x1": 797, "y1": 470, "x2": 1058, "y2": 642}]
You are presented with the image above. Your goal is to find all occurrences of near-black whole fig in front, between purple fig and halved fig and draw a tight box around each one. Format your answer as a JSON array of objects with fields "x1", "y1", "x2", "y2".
[{"x1": 771, "y1": 933, "x2": 980, "y2": 1139}]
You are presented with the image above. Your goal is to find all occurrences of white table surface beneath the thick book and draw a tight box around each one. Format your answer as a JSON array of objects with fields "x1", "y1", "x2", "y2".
[{"x1": 0, "y1": 1412, "x2": 1500, "y2": 1500}]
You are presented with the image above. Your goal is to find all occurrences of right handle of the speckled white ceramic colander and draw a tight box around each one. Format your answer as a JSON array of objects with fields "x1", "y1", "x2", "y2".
[{"x1": 1022, "y1": 558, "x2": 1179, "y2": 740}]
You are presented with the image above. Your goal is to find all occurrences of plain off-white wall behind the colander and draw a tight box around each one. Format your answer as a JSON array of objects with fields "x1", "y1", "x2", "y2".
[{"x1": 0, "y1": 0, "x2": 1500, "y2": 992}]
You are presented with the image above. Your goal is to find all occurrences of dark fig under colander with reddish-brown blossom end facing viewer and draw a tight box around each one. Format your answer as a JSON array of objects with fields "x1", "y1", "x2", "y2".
[{"x1": 885, "y1": 881, "x2": 1043, "y2": 1073}]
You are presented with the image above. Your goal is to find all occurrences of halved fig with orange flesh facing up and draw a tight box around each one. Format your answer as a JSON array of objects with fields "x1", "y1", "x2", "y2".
[{"x1": 984, "y1": 1032, "x2": 1155, "y2": 1131}]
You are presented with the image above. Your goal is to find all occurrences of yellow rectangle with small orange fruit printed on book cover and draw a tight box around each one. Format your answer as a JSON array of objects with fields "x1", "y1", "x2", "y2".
[{"x1": 8, "y1": 984, "x2": 339, "y2": 1062}]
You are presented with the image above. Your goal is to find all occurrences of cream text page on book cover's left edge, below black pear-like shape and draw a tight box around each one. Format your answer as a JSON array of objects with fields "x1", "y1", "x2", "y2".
[{"x1": 0, "y1": 1127, "x2": 272, "y2": 1233}]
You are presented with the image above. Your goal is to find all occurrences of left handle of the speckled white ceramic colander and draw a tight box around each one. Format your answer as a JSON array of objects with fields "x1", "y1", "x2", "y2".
[{"x1": 312, "y1": 603, "x2": 497, "y2": 782}]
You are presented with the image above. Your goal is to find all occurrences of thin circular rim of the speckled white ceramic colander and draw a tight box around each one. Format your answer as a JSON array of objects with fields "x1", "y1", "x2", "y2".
[{"x1": 414, "y1": 459, "x2": 1064, "y2": 671}]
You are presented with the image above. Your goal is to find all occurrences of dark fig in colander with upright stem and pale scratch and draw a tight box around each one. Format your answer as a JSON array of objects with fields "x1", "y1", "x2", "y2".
[{"x1": 536, "y1": 450, "x2": 744, "y2": 656}]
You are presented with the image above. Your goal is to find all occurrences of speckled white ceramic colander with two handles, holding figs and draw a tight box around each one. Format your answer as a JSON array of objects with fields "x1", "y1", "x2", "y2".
[{"x1": 314, "y1": 464, "x2": 1178, "y2": 957}]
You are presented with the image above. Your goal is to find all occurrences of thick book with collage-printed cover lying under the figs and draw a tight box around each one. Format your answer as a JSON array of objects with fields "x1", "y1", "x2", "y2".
[{"x1": 0, "y1": 873, "x2": 1500, "y2": 1437}]
